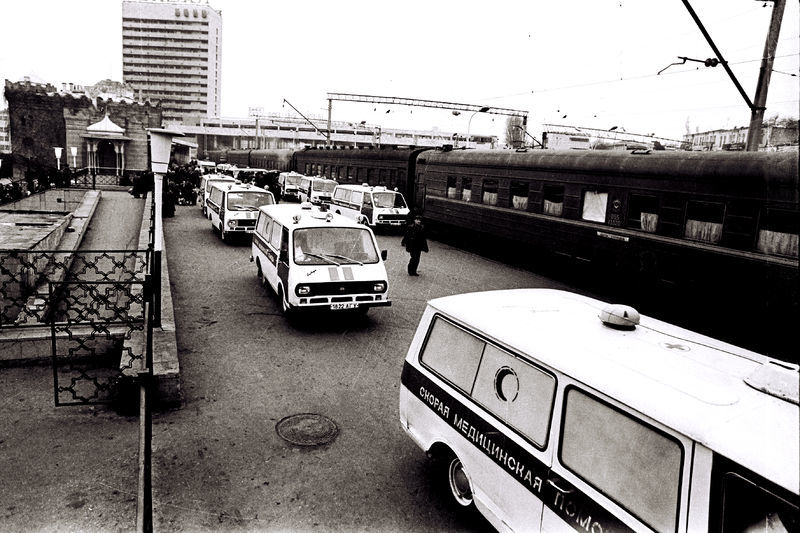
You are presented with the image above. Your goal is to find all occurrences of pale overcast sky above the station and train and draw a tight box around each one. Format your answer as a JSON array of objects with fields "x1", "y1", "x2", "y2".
[{"x1": 0, "y1": 0, "x2": 800, "y2": 139}]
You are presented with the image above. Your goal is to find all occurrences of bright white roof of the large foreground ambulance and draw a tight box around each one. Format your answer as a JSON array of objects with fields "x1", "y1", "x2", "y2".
[{"x1": 429, "y1": 289, "x2": 800, "y2": 494}]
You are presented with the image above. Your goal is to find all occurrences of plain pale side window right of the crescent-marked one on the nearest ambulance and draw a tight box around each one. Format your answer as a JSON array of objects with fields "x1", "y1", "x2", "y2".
[{"x1": 558, "y1": 387, "x2": 683, "y2": 532}]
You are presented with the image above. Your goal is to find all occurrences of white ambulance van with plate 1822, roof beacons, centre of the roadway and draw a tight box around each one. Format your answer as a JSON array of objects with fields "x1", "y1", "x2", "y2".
[{"x1": 250, "y1": 202, "x2": 391, "y2": 315}]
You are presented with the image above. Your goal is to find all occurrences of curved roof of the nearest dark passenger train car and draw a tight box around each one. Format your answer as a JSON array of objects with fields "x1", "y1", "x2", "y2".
[{"x1": 418, "y1": 150, "x2": 798, "y2": 189}]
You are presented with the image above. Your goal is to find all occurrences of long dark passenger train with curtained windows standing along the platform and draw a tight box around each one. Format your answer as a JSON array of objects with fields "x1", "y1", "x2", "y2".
[{"x1": 203, "y1": 148, "x2": 800, "y2": 360}]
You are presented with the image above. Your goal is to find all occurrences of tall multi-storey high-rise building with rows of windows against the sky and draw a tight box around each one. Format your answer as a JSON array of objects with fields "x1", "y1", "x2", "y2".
[{"x1": 122, "y1": 0, "x2": 222, "y2": 124}]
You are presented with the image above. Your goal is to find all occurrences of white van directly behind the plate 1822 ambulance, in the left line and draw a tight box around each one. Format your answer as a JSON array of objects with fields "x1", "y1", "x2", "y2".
[{"x1": 207, "y1": 181, "x2": 275, "y2": 241}]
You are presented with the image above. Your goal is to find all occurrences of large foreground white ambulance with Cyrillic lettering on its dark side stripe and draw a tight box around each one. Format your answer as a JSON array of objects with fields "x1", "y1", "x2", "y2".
[{"x1": 399, "y1": 289, "x2": 800, "y2": 533}]
